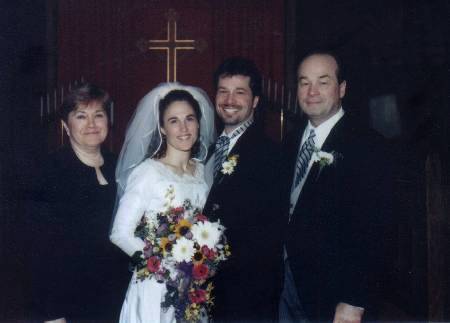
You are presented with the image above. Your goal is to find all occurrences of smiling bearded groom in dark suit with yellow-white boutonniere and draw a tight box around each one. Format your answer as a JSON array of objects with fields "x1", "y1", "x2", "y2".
[{"x1": 204, "y1": 57, "x2": 282, "y2": 322}]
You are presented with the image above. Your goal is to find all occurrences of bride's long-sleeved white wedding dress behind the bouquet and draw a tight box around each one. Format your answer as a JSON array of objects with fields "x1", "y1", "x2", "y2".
[{"x1": 111, "y1": 159, "x2": 208, "y2": 323}]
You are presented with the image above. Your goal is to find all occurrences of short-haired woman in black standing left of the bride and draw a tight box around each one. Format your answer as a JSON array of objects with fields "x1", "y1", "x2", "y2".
[{"x1": 39, "y1": 84, "x2": 128, "y2": 322}]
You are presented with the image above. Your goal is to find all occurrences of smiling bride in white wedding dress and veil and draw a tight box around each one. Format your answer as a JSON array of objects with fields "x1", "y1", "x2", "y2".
[{"x1": 110, "y1": 83, "x2": 215, "y2": 323}]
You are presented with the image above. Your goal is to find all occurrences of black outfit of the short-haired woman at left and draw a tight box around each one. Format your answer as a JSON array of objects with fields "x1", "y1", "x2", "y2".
[{"x1": 36, "y1": 147, "x2": 130, "y2": 322}]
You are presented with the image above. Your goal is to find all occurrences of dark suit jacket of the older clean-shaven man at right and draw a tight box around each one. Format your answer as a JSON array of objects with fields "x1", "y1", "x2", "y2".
[{"x1": 285, "y1": 114, "x2": 391, "y2": 321}]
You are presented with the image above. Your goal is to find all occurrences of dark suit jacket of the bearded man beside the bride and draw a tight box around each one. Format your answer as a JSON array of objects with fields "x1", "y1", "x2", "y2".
[{"x1": 204, "y1": 124, "x2": 283, "y2": 322}]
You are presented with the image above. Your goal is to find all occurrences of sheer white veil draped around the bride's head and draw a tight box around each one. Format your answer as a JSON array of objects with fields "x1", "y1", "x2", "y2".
[{"x1": 114, "y1": 83, "x2": 216, "y2": 223}]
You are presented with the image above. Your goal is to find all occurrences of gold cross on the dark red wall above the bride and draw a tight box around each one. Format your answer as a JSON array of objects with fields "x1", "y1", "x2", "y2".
[{"x1": 148, "y1": 9, "x2": 196, "y2": 82}]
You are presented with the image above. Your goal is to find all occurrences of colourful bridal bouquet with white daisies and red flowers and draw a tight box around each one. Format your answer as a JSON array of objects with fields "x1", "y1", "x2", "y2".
[{"x1": 135, "y1": 192, "x2": 230, "y2": 322}]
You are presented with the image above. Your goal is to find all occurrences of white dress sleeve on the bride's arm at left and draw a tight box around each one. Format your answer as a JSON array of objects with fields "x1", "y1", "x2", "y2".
[{"x1": 110, "y1": 165, "x2": 151, "y2": 256}]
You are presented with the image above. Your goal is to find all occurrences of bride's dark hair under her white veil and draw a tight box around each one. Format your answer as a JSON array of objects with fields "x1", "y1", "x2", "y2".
[{"x1": 155, "y1": 90, "x2": 202, "y2": 159}]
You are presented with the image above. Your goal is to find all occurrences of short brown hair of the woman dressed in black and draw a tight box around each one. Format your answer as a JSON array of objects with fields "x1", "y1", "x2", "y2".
[{"x1": 59, "y1": 83, "x2": 111, "y2": 122}]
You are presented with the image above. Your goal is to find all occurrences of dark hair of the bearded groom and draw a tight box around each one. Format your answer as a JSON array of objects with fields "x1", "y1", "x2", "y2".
[{"x1": 214, "y1": 56, "x2": 262, "y2": 96}]
